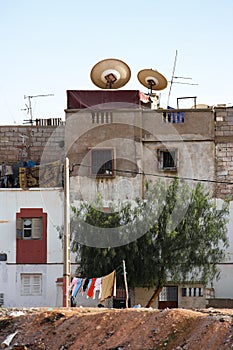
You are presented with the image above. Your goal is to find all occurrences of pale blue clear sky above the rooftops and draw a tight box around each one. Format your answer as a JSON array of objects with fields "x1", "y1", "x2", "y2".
[{"x1": 0, "y1": 0, "x2": 233, "y2": 125}]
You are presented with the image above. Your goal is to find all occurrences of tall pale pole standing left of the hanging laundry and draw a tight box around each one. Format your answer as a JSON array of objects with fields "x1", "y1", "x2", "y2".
[{"x1": 62, "y1": 157, "x2": 70, "y2": 307}]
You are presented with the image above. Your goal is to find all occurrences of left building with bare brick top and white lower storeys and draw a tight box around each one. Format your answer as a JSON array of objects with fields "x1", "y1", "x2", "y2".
[{"x1": 0, "y1": 121, "x2": 67, "y2": 307}]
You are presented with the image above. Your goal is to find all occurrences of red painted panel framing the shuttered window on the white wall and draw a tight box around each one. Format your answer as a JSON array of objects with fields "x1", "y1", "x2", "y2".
[{"x1": 16, "y1": 208, "x2": 47, "y2": 264}]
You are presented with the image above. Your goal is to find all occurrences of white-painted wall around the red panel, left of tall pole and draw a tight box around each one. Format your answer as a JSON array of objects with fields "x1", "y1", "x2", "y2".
[{"x1": 0, "y1": 188, "x2": 67, "y2": 307}]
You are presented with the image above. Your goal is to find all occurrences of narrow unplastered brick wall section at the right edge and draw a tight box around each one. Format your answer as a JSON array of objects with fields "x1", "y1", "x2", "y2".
[{"x1": 215, "y1": 108, "x2": 233, "y2": 200}]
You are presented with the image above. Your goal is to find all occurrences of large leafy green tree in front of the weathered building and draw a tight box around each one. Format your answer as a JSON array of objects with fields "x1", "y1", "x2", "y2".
[{"x1": 68, "y1": 179, "x2": 229, "y2": 307}]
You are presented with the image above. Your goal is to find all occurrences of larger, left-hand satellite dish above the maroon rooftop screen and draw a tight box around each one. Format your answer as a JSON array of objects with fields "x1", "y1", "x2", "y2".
[{"x1": 91, "y1": 58, "x2": 131, "y2": 89}]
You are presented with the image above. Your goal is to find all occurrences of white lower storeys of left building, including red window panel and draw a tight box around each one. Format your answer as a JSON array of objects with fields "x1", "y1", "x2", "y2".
[{"x1": 0, "y1": 188, "x2": 64, "y2": 307}]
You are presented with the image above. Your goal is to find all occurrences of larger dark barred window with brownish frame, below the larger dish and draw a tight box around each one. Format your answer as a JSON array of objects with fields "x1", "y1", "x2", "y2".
[{"x1": 91, "y1": 148, "x2": 114, "y2": 177}]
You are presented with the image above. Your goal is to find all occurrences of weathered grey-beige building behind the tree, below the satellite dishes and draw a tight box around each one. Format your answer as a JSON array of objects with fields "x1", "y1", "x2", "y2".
[{"x1": 65, "y1": 90, "x2": 233, "y2": 307}]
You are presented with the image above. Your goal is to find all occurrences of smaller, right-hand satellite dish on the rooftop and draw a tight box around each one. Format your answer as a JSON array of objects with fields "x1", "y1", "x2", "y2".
[{"x1": 138, "y1": 69, "x2": 167, "y2": 93}]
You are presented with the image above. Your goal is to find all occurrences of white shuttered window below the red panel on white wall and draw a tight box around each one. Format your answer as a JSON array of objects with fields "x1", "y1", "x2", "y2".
[{"x1": 21, "y1": 273, "x2": 42, "y2": 295}]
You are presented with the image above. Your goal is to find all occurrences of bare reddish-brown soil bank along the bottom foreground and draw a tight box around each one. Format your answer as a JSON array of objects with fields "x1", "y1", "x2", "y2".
[{"x1": 0, "y1": 307, "x2": 233, "y2": 350}]
